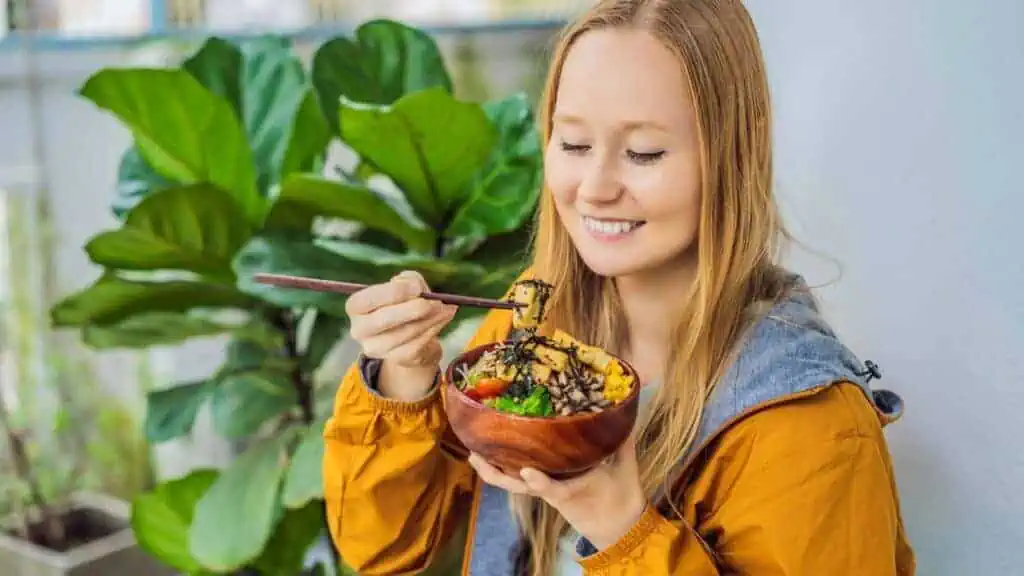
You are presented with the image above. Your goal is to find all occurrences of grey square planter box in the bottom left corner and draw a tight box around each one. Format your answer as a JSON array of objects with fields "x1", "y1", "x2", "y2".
[{"x1": 0, "y1": 487, "x2": 175, "y2": 576}]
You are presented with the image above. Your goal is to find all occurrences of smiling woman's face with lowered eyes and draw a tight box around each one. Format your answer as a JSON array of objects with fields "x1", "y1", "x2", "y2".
[{"x1": 545, "y1": 30, "x2": 700, "y2": 277}]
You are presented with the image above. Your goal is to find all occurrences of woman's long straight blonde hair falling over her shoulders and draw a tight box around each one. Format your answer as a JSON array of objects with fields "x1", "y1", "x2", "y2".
[{"x1": 511, "y1": 0, "x2": 788, "y2": 576}]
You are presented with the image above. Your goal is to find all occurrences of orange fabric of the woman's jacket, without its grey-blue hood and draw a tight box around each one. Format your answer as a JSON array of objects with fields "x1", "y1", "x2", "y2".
[{"x1": 324, "y1": 301, "x2": 915, "y2": 576}]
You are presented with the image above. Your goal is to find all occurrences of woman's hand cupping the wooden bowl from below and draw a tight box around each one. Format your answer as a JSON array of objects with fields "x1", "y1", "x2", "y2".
[{"x1": 469, "y1": 437, "x2": 647, "y2": 549}]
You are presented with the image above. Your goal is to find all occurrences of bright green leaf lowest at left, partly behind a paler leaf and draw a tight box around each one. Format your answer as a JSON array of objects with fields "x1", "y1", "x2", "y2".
[{"x1": 131, "y1": 469, "x2": 219, "y2": 575}]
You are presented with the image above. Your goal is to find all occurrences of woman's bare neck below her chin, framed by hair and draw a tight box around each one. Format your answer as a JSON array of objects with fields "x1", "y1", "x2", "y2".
[{"x1": 615, "y1": 258, "x2": 695, "y2": 382}]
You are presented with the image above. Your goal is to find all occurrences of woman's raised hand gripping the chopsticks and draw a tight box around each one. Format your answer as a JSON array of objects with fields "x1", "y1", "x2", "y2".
[{"x1": 345, "y1": 271, "x2": 459, "y2": 401}]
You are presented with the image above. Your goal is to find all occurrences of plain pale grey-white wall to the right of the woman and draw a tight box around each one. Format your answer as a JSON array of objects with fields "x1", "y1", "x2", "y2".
[{"x1": 748, "y1": 0, "x2": 1024, "y2": 576}]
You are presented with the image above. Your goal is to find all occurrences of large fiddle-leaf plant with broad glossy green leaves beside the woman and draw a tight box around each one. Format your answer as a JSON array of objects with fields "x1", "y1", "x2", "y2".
[{"x1": 51, "y1": 20, "x2": 541, "y2": 574}]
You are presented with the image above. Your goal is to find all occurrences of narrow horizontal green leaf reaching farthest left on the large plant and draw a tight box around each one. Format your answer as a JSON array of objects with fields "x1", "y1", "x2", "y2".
[{"x1": 50, "y1": 272, "x2": 257, "y2": 326}]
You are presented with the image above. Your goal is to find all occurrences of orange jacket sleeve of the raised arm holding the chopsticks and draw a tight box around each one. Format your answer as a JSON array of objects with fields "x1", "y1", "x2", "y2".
[{"x1": 323, "y1": 313, "x2": 511, "y2": 576}]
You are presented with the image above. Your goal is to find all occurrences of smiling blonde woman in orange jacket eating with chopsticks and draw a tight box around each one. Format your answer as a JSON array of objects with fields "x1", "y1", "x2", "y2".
[{"x1": 325, "y1": 0, "x2": 914, "y2": 576}]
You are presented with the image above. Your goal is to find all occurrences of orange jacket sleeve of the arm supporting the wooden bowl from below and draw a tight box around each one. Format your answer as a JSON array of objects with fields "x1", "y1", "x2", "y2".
[{"x1": 581, "y1": 384, "x2": 913, "y2": 576}]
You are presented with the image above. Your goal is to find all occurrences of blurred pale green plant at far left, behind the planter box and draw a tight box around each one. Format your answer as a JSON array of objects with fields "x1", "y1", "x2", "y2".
[{"x1": 0, "y1": 192, "x2": 153, "y2": 549}]
